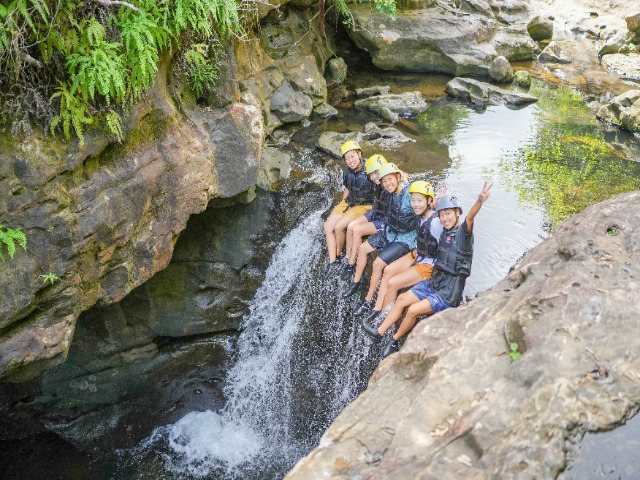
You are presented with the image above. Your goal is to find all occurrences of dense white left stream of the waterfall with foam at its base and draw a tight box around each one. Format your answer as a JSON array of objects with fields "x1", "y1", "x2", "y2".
[{"x1": 117, "y1": 210, "x2": 332, "y2": 478}]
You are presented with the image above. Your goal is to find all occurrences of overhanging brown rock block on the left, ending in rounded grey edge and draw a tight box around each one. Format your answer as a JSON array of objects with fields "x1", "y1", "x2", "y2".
[{"x1": 0, "y1": 86, "x2": 263, "y2": 381}]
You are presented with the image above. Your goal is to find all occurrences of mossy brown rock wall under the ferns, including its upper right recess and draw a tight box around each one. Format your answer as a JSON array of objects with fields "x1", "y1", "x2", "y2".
[{"x1": 0, "y1": 2, "x2": 331, "y2": 381}]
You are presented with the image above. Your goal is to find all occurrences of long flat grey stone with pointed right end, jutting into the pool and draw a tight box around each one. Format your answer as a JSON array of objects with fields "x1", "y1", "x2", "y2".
[{"x1": 445, "y1": 78, "x2": 538, "y2": 109}]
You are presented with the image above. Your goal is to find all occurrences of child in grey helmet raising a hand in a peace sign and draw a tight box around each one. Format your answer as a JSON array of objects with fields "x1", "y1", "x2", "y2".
[{"x1": 366, "y1": 182, "x2": 493, "y2": 357}]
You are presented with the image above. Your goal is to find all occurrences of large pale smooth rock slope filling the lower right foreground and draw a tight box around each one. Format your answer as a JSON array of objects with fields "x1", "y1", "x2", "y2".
[{"x1": 286, "y1": 192, "x2": 640, "y2": 480}]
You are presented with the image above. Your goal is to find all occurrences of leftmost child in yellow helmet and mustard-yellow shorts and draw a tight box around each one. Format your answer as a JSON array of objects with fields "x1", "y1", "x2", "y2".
[{"x1": 324, "y1": 140, "x2": 375, "y2": 272}]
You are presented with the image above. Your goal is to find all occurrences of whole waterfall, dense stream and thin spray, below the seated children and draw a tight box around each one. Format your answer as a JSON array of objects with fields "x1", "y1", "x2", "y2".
[{"x1": 121, "y1": 210, "x2": 377, "y2": 479}]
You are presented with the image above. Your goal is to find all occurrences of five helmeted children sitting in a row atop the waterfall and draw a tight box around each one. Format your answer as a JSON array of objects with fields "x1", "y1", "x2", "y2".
[{"x1": 324, "y1": 141, "x2": 493, "y2": 357}]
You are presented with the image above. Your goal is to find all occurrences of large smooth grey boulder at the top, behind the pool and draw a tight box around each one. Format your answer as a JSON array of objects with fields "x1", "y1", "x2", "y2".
[{"x1": 348, "y1": 0, "x2": 534, "y2": 77}]
